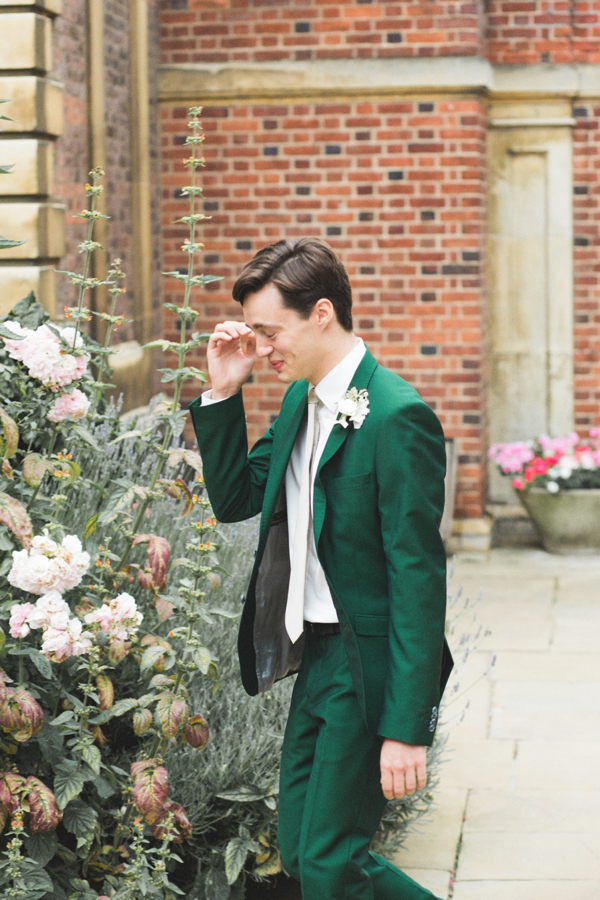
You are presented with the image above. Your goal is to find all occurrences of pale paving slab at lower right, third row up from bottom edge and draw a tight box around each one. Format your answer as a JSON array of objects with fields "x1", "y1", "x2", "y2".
[{"x1": 464, "y1": 790, "x2": 600, "y2": 836}]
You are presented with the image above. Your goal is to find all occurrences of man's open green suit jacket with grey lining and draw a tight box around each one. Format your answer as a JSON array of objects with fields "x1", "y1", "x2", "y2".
[{"x1": 191, "y1": 351, "x2": 452, "y2": 745}]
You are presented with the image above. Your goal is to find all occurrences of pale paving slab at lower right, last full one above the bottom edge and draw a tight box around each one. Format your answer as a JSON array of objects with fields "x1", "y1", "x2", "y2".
[{"x1": 456, "y1": 832, "x2": 600, "y2": 880}]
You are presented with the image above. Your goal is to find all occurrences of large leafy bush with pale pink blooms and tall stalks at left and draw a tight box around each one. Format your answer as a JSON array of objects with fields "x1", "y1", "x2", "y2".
[{"x1": 0, "y1": 110, "x2": 225, "y2": 900}]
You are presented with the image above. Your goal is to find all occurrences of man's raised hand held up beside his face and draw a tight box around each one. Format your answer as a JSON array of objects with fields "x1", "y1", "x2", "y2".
[{"x1": 206, "y1": 322, "x2": 256, "y2": 400}]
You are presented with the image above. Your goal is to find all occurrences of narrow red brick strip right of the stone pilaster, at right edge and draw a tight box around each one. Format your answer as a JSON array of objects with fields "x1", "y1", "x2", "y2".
[{"x1": 573, "y1": 101, "x2": 600, "y2": 432}]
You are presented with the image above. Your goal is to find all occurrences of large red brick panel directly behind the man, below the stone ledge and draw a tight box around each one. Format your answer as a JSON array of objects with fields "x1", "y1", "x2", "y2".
[{"x1": 162, "y1": 98, "x2": 486, "y2": 516}]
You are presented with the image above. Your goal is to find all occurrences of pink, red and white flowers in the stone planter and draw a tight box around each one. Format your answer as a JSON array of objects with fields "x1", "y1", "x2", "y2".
[{"x1": 488, "y1": 428, "x2": 600, "y2": 494}]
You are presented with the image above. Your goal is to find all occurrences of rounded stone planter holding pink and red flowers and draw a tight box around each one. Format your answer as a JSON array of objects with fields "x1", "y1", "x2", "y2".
[{"x1": 517, "y1": 488, "x2": 600, "y2": 554}]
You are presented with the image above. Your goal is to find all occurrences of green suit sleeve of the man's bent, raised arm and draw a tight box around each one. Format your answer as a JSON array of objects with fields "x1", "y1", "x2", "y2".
[{"x1": 190, "y1": 391, "x2": 274, "y2": 522}]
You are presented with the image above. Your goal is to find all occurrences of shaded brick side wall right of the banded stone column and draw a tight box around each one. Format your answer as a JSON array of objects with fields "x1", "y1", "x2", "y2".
[{"x1": 53, "y1": 0, "x2": 161, "y2": 341}]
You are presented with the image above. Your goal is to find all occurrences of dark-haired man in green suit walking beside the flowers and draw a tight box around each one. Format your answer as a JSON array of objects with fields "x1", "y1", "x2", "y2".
[{"x1": 191, "y1": 238, "x2": 452, "y2": 900}]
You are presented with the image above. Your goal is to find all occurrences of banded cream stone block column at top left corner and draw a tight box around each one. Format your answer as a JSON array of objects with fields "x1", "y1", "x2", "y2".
[{"x1": 0, "y1": 0, "x2": 65, "y2": 314}]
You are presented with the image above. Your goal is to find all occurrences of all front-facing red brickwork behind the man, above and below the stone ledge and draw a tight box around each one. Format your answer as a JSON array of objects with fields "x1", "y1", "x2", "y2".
[{"x1": 161, "y1": 0, "x2": 600, "y2": 516}]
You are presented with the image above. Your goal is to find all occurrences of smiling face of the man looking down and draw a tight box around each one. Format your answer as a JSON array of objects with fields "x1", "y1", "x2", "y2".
[{"x1": 244, "y1": 284, "x2": 326, "y2": 384}]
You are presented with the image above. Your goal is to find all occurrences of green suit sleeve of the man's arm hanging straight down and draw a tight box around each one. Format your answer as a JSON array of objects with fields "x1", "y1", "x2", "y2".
[{"x1": 376, "y1": 401, "x2": 446, "y2": 745}]
